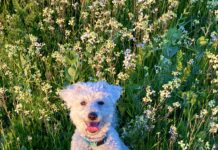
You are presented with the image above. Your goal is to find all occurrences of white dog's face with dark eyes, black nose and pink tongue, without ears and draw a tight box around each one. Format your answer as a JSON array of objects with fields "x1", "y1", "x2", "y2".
[{"x1": 70, "y1": 93, "x2": 114, "y2": 135}]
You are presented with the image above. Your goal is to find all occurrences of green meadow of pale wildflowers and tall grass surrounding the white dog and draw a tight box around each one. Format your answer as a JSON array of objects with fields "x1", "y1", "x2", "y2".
[{"x1": 0, "y1": 0, "x2": 218, "y2": 150}]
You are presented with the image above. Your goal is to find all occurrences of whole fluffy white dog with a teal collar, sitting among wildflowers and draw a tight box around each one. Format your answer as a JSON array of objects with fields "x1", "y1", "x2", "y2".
[{"x1": 60, "y1": 81, "x2": 128, "y2": 150}]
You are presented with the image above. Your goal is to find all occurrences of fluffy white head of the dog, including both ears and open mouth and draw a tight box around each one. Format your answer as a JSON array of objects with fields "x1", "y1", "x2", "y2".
[{"x1": 60, "y1": 81, "x2": 122, "y2": 136}]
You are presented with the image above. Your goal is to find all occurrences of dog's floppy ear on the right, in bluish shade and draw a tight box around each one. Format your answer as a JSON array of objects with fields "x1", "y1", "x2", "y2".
[{"x1": 109, "y1": 85, "x2": 122, "y2": 104}]
